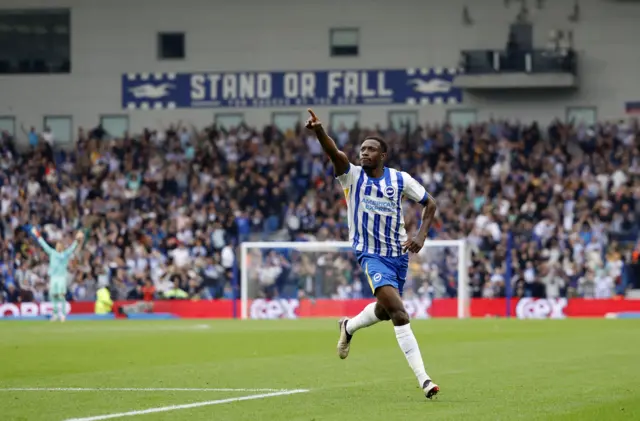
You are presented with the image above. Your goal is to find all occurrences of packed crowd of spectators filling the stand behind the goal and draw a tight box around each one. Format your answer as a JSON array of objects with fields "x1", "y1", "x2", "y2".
[{"x1": 0, "y1": 115, "x2": 640, "y2": 302}]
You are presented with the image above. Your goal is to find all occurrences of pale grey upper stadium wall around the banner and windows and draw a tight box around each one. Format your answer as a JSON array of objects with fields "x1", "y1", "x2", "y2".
[{"x1": 0, "y1": 0, "x2": 640, "y2": 144}]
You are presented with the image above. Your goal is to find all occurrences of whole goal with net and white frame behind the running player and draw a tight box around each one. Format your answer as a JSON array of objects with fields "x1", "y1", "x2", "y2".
[{"x1": 240, "y1": 240, "x2": 470, "y2": 319}]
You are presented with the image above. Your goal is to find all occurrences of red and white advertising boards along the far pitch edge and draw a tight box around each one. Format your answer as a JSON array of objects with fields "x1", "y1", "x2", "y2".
[{"x1": 0, "y1": 298, "x2": 640, "y2": 319}]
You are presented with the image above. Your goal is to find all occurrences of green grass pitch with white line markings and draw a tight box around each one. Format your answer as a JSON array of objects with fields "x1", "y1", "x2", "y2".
[{"x1": 0, "y1": 319, "x2": 640, "y2": 421}]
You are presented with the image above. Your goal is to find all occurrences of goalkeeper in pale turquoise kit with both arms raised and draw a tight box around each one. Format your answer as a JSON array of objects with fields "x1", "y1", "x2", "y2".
[{"x1": 31, "y1": 228, "x2": 84, "y2": 322}]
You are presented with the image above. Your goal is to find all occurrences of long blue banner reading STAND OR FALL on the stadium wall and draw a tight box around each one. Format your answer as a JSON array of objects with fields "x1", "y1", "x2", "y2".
[{"x1": 122, "y1": 67, "x2": 462, "y2": 109}]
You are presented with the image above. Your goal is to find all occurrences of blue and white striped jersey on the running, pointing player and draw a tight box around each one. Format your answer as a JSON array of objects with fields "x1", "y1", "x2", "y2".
[{"x1": 337, "y1": 164, "x2": 429, "y2": 257}]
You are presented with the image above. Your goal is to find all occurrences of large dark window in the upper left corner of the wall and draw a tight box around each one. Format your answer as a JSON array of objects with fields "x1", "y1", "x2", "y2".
[{"x1": 0, "y1": 9, "x2": 71, "y2": 74}]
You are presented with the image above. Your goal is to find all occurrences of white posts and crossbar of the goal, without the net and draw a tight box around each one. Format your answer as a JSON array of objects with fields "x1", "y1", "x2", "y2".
[{"x1": 238, "y1": 240, "x2": 469, "y2": 320}]
